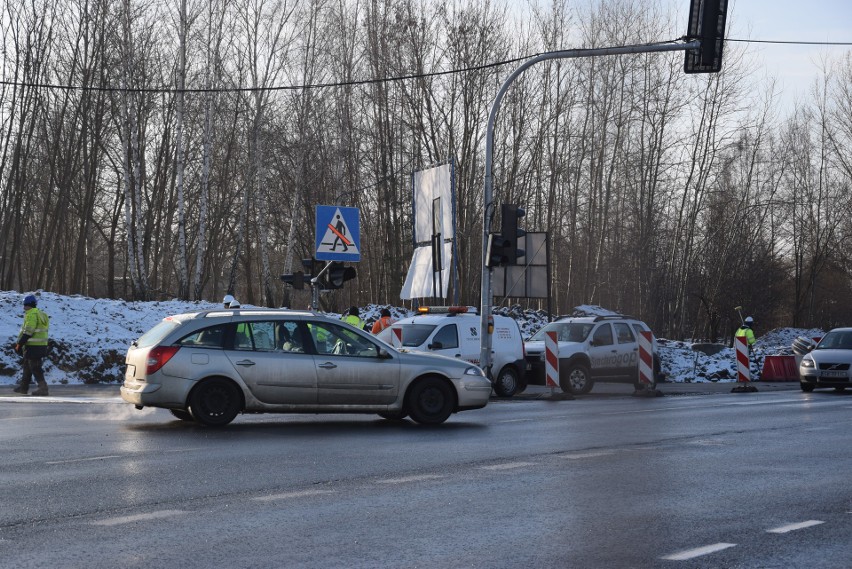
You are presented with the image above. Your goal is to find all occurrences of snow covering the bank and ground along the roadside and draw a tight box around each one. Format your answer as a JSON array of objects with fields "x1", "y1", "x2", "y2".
[{"x1": 0, "y1": 291, "x2": 823, "y2": 385}]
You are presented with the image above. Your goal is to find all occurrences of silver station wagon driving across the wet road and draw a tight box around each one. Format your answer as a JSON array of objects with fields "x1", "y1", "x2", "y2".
[{"x1": 121, "y1": 309, "x2": 491, "y2": 426}]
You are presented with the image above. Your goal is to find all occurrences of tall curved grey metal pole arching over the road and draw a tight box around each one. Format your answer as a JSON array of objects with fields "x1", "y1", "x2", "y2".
[{"x1": 479, "y1": 40, "x2": 701, "y2": 377}]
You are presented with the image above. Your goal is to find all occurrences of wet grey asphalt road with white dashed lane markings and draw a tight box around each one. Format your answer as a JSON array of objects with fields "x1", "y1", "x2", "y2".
[{"x1": 0, "y1": 384, "x2": 852, "y2": 568}]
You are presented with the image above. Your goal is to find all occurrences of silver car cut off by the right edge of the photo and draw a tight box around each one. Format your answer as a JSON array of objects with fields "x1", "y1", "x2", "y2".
[{"x1": 799, "y1": 328, "x2": 852, "y2": 392}]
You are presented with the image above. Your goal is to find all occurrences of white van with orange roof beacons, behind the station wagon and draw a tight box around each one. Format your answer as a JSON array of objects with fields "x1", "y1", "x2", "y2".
[{"x1": 378, "y1": 306, "x2": 527, "y2": 397}]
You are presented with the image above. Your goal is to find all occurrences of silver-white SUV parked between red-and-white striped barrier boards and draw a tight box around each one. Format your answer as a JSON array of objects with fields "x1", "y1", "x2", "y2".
[{"x1": 524, "y1": 315, "x2": 660, "y2": 395}]
